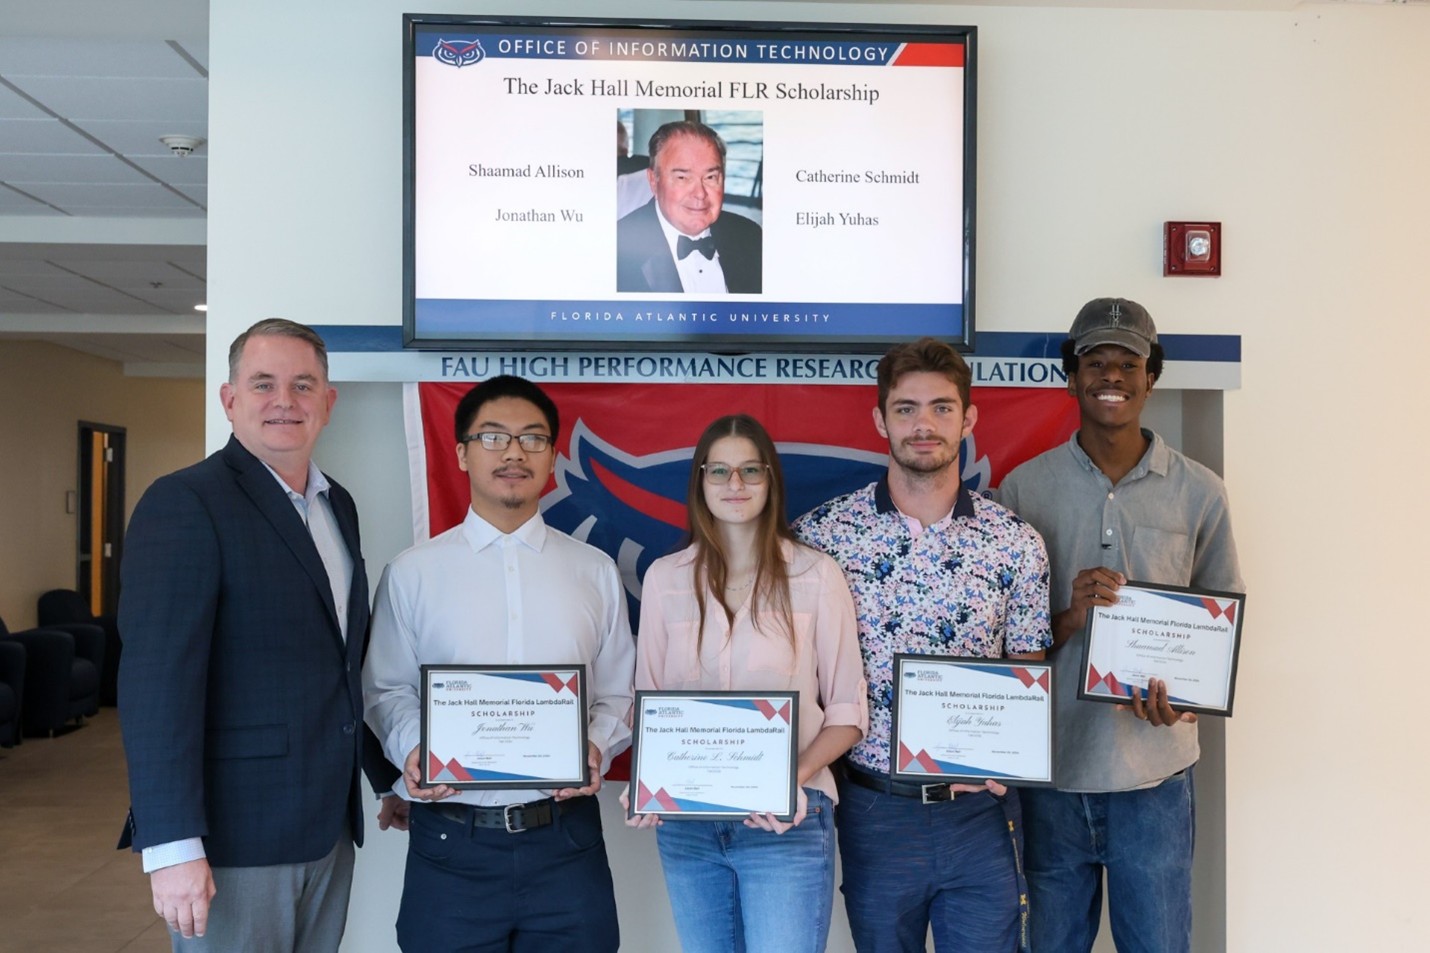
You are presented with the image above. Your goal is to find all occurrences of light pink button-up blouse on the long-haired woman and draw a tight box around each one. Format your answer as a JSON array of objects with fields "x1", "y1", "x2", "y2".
[{"x1": 635, "y1": 544, "x2": 869, "y2": 801}]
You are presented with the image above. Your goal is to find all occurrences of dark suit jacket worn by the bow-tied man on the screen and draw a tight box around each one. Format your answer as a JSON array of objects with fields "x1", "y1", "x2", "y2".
[{"x1": 616, "y1": 199, "x2": 764, "y2": 295}]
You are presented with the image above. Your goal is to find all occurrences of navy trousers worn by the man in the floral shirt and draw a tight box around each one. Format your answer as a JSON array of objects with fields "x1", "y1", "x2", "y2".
[{"x1": 839, "y1": 781, "x2": 1041, "y2": 953}]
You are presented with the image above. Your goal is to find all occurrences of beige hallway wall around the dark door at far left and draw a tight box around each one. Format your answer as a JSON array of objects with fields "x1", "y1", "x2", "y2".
[{"x1": 0, "y1": 341, "x2": 204, "y2": 630}]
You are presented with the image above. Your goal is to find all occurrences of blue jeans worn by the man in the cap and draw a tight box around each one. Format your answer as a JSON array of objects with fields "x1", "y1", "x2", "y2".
[{"x1": 1022, "y1": 768, "x2": 1197, "y2": 953}]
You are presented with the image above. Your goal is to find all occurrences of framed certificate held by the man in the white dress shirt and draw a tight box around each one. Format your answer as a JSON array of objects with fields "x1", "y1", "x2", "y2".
[{"x1": 422, "y1": 665, "x2": 591, "y2": 788}]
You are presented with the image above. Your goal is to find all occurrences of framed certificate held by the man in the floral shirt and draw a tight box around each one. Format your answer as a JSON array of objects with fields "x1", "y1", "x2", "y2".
[{"x1": 889, "y1": 653, "x2": 1052, "y2": 787}]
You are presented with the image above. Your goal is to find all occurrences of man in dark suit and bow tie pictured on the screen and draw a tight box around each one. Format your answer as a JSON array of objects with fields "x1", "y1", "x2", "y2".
[{"x1": 616, "y1": 122, "x2": 764, "y2": 295}]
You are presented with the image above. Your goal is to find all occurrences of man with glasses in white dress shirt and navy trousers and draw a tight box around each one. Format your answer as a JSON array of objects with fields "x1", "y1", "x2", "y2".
[{"x1": 363, "y1": 375, "x2": 635, "y2": 952}]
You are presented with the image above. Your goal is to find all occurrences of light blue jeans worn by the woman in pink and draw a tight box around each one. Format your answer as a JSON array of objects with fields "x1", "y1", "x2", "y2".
[{"x1": 656, "y1": 788, "x2": 834, "y2": 953}]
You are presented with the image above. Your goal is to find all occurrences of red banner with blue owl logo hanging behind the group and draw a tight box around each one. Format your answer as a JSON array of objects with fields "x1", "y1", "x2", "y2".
[{"x1": 413, "y1": 383, "x2": 1077, "y2": 540}]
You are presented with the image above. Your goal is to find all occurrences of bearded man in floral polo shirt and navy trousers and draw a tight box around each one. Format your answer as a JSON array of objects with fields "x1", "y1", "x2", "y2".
[{"x1": 795, "y1": 338, "x2": 1052, "y2": 953}]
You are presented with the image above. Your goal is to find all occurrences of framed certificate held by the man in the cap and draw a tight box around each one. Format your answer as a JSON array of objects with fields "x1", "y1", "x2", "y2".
[{"x1": 1077, "y1": 582, "x2": 1246, "y2": 715}]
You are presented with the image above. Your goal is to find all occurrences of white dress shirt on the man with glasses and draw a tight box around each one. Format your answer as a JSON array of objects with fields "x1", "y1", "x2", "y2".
[{"x1": 363, "y1": 509, "x2": 635, "y2": 806}]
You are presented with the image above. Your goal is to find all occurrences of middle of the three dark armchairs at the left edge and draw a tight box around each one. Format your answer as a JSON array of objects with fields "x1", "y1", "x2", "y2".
[{"x1": 0, "y1": 609, "x2": 104, "y2": 735}]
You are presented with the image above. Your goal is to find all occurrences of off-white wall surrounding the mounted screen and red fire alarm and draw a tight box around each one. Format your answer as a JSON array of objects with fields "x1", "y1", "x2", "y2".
[{"x1": 209, "y1": 0, "x2": 1430, "y2": 950}]
